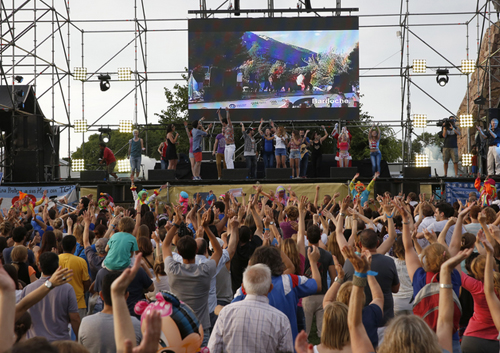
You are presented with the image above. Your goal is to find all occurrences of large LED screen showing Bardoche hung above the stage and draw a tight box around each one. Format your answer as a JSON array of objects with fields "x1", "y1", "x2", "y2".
[{"x1": 188, "y1": 16, "x2": 359, "y2": 121}]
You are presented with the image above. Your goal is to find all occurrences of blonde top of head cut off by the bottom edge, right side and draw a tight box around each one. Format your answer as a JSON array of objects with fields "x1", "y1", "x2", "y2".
[{"x1": 377, "y1": 315, "x2": 442, "y2": 353}]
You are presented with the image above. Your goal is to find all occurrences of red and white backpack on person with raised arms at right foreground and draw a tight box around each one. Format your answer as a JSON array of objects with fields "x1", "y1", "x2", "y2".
[{"x1": 413, "y1": 272, "x2": 462, "y2": 333}]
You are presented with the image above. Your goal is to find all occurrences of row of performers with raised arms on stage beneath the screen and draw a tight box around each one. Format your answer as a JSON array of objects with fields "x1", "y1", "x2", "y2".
[{"x1": 158, "y1": 108, "x2": 382, "y2": 180}]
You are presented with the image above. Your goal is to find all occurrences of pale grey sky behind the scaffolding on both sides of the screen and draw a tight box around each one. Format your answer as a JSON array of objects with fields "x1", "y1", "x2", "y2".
[{"x1": 1, "y1": 0, "x2": 484, "y2": 157}]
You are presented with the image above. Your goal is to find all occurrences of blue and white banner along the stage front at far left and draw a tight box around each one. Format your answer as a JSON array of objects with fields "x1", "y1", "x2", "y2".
[{"x1": 0, "y1": 185, "x2": 78, "y2": 208}]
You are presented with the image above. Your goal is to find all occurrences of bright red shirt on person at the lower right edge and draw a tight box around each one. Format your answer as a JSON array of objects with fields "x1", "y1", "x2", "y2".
[{"x1": 462, "y1": 273, "x2": 498, "y2": 340}]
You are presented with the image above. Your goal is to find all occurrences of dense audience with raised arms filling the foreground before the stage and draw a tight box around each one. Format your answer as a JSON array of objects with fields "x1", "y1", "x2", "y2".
[{"x1": 0, "y1": 182, "x2": 500, "y2": 353}]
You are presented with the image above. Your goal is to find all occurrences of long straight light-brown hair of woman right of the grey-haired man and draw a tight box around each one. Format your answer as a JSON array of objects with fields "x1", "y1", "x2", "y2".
[{"x1": 321, "y1": 302, "x2": 351, "y2": 350}]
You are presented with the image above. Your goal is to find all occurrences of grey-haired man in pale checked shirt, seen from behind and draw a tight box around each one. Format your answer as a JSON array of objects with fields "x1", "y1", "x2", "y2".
[{"x1": 208, "y1": 264, "x2": 294, "y2": 353}]
